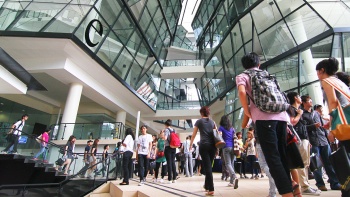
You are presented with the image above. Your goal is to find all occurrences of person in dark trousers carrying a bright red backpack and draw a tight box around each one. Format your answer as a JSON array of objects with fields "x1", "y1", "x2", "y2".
[{"x1": 164, "y1": 119, "x2": 181, "y2": 183}]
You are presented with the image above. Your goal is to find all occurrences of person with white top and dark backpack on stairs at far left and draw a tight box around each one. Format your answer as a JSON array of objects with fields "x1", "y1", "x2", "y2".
[{"x1": 1, "y1": 114, "x2": 28, "y2": 154}]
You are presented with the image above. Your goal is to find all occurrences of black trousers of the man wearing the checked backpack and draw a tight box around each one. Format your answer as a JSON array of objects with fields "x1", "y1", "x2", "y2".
[{"x1": 255, "y1": 120, "x2": 293, "y2": 195}]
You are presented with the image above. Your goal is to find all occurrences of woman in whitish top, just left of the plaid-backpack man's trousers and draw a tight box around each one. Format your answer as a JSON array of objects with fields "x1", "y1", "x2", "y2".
[{"x1": 244, "y1": 128, "x2": 259, "y2": 179}]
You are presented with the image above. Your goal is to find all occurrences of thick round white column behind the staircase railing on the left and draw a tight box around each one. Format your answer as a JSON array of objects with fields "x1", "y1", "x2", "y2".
[{"x1": 57, "y1": 83, "x2": 83, "y2": 140}]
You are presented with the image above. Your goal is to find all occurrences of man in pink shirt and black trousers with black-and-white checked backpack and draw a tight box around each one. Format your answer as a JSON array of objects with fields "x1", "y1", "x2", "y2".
[{"x1": 236, "y1": 52, "x2": 294, "y2": 197}]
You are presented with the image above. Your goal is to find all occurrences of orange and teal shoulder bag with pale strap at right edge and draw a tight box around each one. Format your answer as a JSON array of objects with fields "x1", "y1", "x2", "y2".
[{"x1": 323, "y1": 78, "x2": 350, "y2": 141}]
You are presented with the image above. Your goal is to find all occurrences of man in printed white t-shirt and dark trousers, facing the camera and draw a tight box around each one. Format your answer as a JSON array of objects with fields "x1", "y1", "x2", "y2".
[{"x1": 137, "y1": 125, "x2": 152, "y2": 186}]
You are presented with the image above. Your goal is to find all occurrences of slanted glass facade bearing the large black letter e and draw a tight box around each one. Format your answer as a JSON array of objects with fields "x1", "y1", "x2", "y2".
[{"x1": 0, "y1": 0, "x2": 182, "y2": 110}]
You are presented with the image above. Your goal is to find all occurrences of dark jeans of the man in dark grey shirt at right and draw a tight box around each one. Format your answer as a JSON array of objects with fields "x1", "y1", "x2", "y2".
[{"x1": 311, "y1": 145, "x2": 339, "y2": 189}]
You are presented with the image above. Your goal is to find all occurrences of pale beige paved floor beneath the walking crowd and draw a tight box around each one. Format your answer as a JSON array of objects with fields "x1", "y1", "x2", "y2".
[{"x1": 122, "y1": 173, "x2": 341, "y2": 197}]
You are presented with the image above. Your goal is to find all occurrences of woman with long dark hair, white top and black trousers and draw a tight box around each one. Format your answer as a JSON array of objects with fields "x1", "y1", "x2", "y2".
[{"x1": 119, "y1": 128, "x2": 135, "y2": 185}]
